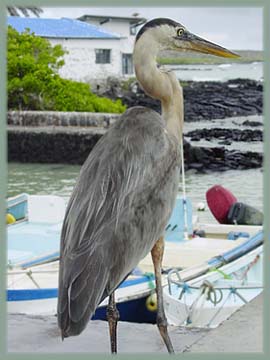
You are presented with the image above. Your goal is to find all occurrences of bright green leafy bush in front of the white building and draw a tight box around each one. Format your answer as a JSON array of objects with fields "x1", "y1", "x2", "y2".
[{"x1": 8, "y1": 27, "x2": 125, "y2": 113}]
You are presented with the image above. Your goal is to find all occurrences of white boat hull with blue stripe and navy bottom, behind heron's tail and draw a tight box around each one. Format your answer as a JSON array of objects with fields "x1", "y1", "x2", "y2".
[{"x1": 7, "y1": 261, "x2": 156, "y2": 323}]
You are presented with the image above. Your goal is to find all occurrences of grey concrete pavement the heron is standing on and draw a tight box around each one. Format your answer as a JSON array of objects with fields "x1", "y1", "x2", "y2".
[{"x1": 7, "y1": 295, "x2": 263, "y2": 353}]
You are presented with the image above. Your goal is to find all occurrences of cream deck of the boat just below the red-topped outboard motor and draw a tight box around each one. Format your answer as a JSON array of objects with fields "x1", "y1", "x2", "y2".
[{"x1": 140, "y1": 218, "x2": 262, "y2": 272}]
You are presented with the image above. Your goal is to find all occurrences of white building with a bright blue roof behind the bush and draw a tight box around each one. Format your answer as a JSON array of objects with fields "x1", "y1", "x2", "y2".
[{"x1": 8, "y1": 15, "x2": 145, "y2": 85}]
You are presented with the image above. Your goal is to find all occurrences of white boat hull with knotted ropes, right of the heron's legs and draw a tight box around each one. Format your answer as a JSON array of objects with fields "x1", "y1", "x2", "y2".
[{"x1": 164, "y1": 246, "x2": 263, "y2": 328}]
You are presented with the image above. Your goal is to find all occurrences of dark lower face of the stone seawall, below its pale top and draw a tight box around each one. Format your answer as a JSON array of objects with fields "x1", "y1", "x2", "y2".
[{"x1": 8, "y1": 127, "x2": 106, "y2": 164}]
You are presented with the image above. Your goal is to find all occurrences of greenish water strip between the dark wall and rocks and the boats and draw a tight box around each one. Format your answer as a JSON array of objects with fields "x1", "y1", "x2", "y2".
[{"x1": 8, "y1": 153, "x2": 263, "y2": 223}]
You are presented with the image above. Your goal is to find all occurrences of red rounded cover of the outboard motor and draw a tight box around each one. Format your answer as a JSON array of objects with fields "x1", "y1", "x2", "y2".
[{"x1": 206, "y1": 185, "x2": 237, "y2": 224}]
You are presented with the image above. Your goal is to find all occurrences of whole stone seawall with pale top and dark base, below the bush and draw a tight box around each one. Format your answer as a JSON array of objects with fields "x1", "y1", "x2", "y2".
[{"x1": 7, "y1": 111, "x2": 120, "y2": 164}]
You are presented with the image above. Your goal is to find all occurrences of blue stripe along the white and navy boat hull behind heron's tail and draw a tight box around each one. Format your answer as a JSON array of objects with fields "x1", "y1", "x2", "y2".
[{"x1": 7, "y1": 276, "x2": 149, "y2": 301}]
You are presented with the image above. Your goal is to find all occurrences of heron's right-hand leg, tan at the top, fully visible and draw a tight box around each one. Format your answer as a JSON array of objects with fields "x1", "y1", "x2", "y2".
[{"x1": 151, "y1": 236, "x2": 174, "y2": 353}]
